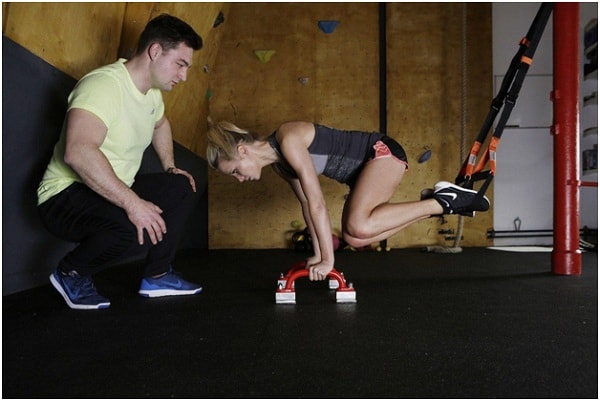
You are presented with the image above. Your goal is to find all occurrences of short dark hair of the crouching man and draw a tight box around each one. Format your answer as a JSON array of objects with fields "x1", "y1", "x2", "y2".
[{"x1": 136, "y1": 14, "x2": 202, "y2": 54}]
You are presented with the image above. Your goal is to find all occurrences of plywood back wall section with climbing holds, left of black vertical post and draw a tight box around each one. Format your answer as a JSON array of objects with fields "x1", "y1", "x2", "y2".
[{"x1": 209, "y1": 3, "x2": 379, "y2": 248}]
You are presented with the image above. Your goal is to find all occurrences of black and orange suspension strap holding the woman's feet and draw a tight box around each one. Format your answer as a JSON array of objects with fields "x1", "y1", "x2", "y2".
[{"x1": 455, "y1": 3, "x2": 553, "y2": 202}]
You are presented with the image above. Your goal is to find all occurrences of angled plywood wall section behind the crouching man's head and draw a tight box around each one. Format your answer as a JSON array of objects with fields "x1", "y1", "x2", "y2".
[{"x1": 2, "y1": 2, "x2": 229, "y2": 153}]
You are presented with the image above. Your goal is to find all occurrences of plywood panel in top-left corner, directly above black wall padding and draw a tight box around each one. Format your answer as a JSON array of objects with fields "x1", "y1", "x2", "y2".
[{"x1": 4, "y1": 2, "x2": 126, "y2": 79}]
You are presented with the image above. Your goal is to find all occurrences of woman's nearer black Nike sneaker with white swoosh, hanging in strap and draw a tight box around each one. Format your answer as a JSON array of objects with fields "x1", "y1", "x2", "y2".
[{"x1": 433, "y1": 181, "x2": 490, "y2": 217}]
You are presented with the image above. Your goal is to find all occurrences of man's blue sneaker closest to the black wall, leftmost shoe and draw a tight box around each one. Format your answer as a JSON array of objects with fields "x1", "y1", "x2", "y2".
[{"x1": 50, "y1": 269, "x2": 110, "y2": 309}]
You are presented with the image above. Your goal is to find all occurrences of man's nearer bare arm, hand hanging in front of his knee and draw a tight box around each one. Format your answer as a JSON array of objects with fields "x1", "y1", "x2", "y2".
[{"x1": 65, "y1": 108, "x2": 167, "y2": 244}]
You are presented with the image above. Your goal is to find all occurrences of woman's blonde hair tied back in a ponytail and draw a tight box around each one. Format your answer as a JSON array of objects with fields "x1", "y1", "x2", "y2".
[{"x1": 206, "y1": 117, "x2": 257, "y2": 169}]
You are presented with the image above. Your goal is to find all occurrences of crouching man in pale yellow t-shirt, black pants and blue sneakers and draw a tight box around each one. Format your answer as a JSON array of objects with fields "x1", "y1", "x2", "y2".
[{"x1": 38, "y1": 14, "x2": 202, "y2": 309}]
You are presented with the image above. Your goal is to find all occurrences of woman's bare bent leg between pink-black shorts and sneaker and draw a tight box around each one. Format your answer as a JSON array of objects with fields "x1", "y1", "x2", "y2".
[{"x1": 342, "y1": 156, "x2": 443, "y2": 247}]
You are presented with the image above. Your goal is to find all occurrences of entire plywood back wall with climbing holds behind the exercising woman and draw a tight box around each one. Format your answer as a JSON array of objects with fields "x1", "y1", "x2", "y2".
[{"x1": 209, "y1": 3, "x2": 492, "y2": 248}]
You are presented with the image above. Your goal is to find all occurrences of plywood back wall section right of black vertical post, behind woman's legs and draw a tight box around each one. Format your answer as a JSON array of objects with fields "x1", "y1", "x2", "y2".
[{"x1": 387, "y1": 3, "x2": 493, "y2": 246}]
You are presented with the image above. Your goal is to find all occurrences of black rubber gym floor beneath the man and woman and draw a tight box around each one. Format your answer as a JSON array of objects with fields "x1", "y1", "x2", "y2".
[{"x1": 2, "y1": 248, "x2": 598, "y2": 399}]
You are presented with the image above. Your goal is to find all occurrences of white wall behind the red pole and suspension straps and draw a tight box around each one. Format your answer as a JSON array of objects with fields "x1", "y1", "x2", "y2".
[{"x1": 492, "y1": 3, "x2": 598, "y2": 245}]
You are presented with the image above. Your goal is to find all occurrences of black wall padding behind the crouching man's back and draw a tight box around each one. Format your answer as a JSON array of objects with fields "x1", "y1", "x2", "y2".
[{"x1": 2, "y1": 36, "x2": 76, "y2": 294}]
